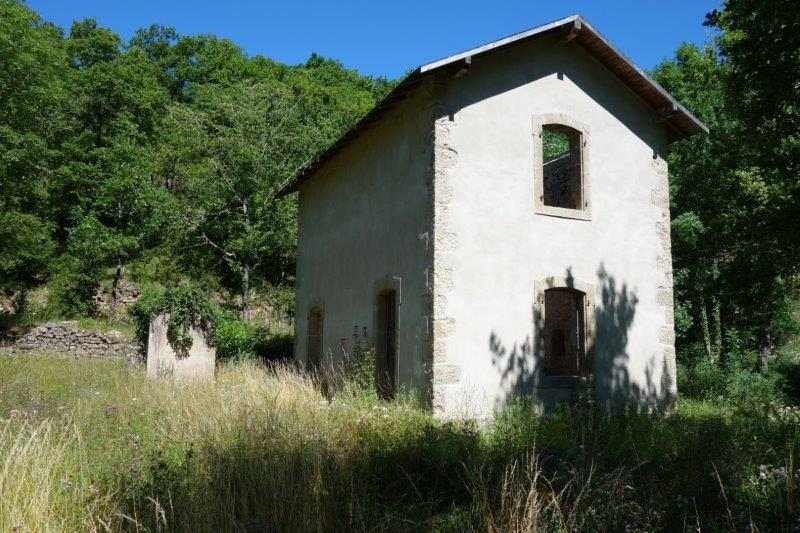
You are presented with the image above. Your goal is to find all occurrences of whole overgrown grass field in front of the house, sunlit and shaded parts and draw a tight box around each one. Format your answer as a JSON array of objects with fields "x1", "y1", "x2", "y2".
[{"x1": 0, "y1": 355, "x2": 798, "y2": 531}]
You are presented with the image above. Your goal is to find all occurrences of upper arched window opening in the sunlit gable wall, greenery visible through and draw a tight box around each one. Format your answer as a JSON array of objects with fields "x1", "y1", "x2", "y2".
[{"x1": 542, "y1": 124, "x2": 583, "y2": 209}]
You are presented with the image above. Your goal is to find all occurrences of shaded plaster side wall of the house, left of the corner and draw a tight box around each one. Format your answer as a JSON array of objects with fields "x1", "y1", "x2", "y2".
[{"x1": 295, "y1": 88, "x2": 433, "y2": 393}]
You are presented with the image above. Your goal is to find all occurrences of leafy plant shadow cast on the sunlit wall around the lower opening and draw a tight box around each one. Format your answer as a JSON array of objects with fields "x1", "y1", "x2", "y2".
[{"x1": 489, "y1": 264, "x2": 674, "y2": 412}]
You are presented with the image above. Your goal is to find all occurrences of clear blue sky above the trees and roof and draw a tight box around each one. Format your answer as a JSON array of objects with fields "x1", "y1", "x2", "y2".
[{"x1": 27, "y1": 0, "x2": 720, "y2": 78}]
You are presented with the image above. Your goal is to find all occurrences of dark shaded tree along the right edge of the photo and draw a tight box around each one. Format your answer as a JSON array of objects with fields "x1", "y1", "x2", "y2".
[{"x1": 706, "y1": 0, "x2": 800, "y2": 366}]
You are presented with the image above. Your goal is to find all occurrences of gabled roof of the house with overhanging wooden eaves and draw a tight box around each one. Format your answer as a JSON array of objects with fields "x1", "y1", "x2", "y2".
[{"x1": 278, "y1": 15, "x2": 708, "y2": 196}]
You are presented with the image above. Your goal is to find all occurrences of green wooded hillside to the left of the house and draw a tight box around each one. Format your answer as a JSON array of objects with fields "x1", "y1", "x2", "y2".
[{"x1": 0, "y1": 0, "x2": 390, "y2": 318}]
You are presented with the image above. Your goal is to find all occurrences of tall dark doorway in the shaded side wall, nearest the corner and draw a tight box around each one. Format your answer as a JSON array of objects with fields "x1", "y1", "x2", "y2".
[{"x1": 375, "y1": 290, "x2": 397, "y2": 400}]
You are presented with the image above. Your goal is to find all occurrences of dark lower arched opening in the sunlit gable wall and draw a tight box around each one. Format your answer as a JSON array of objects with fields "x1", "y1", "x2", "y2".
[{"x1": 543, "y1": 287, "x2": 588, "y2": 376}]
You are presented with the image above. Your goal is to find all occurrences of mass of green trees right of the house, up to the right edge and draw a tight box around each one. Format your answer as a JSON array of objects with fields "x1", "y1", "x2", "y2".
[{"x1": 654, "y1": 0, "x2": 800, "y2": 367}]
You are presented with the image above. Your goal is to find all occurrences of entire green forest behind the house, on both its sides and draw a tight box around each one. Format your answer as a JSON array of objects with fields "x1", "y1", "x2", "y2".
[{"x1": 0, "y1": 0, "x2": 800, "y2": 373}]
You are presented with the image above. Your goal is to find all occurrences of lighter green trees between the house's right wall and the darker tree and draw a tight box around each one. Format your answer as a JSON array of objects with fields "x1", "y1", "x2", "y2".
[{"x1": 653, "y1": 44, "x2": 736, "y2": 359}]
